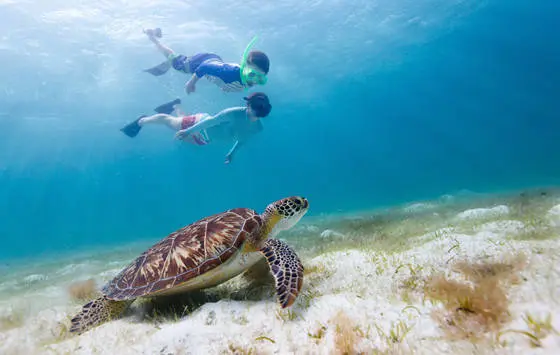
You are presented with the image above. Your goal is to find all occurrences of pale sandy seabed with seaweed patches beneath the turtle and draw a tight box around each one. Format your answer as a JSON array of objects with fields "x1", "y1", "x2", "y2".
[{"x1": 0, "y1": 192, "x2": 560, "y2": 354}]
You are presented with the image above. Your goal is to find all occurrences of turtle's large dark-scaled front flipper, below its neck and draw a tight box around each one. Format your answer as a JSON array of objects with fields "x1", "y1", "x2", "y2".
[{"x1": 260, "y1": 239, "x2": 303, "y2": 308}]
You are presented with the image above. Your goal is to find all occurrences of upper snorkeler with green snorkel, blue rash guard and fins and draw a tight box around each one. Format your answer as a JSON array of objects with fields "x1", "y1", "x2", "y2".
[{"x1": 144, "y1": 28, "x2": 270, "y2": 94}]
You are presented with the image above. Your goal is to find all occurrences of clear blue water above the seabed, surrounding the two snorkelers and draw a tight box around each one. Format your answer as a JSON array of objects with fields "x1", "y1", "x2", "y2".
[{"x1": 0, "y1": 0, "x2": 560, "y2": 259}]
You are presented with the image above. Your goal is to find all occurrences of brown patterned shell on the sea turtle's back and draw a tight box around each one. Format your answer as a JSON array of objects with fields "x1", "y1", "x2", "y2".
[{"x1": 103, "y1": 208, "x2": 263, "y2": 300}]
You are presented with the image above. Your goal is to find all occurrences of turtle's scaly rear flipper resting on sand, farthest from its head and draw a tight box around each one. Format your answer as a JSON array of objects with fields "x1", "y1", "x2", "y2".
[{"x1": 70, "y1": 296, "x2": 131, "y2": 334}]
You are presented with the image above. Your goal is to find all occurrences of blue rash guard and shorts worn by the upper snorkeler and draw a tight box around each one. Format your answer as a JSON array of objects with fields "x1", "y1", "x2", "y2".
[{"x1": 170, "y1": 53, "x2": 244, "y2": 92}]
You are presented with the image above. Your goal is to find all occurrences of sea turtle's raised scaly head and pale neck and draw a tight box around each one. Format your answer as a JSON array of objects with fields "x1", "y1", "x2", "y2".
[{"x1": 263, "y1": 196, "x2": 309, "y2": 238}]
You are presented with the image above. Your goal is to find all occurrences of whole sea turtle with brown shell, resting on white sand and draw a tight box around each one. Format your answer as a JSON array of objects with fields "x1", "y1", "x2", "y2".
[{"x1": 70, "y1": 196, "x2": 309, "y2": 334}]
